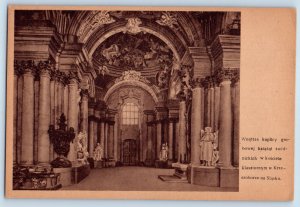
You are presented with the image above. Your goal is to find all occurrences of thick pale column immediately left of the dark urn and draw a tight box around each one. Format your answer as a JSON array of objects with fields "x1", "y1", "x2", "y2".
[{"x1": 38, "y1": 63, "x2": 51, "y2": 165}]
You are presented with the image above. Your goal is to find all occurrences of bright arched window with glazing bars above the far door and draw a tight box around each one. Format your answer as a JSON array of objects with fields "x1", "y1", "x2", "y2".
[{"x1": 122, "y1": 103, "x2": 139, "y2": 125}]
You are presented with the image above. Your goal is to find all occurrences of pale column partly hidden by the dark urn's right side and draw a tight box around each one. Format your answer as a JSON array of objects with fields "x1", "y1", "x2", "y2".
[{"x1": 68, "y1": 74, "x2": 79, "y2": 162}]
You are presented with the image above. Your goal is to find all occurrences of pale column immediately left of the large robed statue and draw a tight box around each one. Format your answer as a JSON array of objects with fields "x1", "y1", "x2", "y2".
[{"x1": 191, "y1": 85, "x2": 202, "y2": 165}]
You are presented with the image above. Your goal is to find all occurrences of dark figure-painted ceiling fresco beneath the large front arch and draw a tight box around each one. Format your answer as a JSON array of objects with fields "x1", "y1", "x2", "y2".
[{"x1": 93, "y1": 32, "x2": 173, "y2": 70}]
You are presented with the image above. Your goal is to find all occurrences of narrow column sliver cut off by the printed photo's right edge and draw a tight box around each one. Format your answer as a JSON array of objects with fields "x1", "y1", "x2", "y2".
[{"x1": 233, "y1": 81, "x2": 240, "y2": 167}]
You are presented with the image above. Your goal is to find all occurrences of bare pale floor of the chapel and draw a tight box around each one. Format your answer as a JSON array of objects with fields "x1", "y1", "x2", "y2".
[{"x1": 62, "y1": 167, "x2": 237, "y2": 191}]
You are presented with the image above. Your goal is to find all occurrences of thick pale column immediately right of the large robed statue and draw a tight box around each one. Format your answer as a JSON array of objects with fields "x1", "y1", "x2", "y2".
[{"x1": 219, "y1": 80, "x2": 232, "y2": 167}]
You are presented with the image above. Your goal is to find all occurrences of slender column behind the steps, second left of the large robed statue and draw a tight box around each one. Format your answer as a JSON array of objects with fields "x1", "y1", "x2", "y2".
[{"x1": 178, "y1": 99, "x2": 187, "y2": 163}]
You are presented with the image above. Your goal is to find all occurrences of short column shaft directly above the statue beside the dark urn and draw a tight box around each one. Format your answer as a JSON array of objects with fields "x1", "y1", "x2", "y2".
[{"x1": 80, "y1": 90, "x2": 89, "y2": 135}]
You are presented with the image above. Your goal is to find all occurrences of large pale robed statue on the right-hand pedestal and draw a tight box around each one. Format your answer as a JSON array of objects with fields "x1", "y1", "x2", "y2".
[{"x1": 200, "y1": 127, "x2": 219, "y2": 166}]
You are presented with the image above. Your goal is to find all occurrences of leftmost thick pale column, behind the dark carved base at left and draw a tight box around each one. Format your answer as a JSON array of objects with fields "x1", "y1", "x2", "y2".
[{"x1": 21, "y1": 62, "x2": 34, "y2": 165}]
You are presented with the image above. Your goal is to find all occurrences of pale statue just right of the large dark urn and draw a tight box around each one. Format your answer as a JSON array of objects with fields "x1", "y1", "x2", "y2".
[{"x1": 76, "y1": 131, "x2": 89, "y2": 164}]
